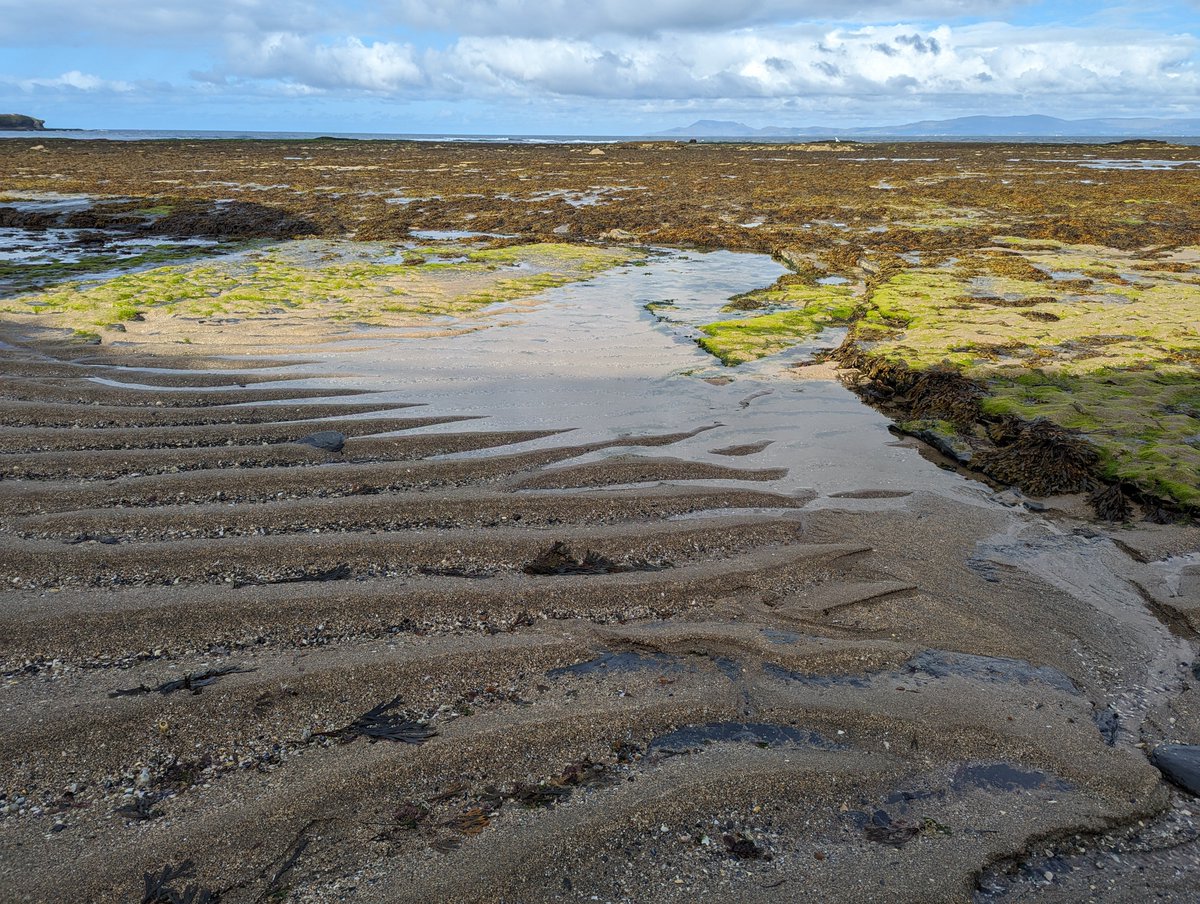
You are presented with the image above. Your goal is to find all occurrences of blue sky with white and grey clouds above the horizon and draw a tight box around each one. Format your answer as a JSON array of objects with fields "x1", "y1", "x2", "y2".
[{"x1": 0, "y1": 0, "x2": 1200, "y2": 136}]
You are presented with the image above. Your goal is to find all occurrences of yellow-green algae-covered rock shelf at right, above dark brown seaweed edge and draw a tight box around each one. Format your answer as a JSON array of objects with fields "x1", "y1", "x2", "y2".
[{"x1": 848, "y1": 241, "x2": 1200, "y2": 505}]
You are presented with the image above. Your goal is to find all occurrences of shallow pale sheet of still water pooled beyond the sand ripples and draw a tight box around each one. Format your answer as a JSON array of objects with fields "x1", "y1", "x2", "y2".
[{"x1": 295, "y1": 251, "x2": 979, "y2": 507}]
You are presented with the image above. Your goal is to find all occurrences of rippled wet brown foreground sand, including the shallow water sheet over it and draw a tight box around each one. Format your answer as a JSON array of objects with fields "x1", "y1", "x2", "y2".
[{"x1": 0, "y1": 144, "x2": 1200, "y2": 903}]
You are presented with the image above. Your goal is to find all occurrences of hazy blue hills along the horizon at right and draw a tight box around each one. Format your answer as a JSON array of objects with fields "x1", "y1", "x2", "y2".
[{"x1": 653, "y1": 115, "x2": 1200, "y2": 138}]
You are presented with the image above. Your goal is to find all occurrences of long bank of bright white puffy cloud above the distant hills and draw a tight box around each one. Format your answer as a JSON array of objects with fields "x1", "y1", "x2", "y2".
[{"x1": 213, "y1": 24, "x2": 1200, "y2": 101}]
